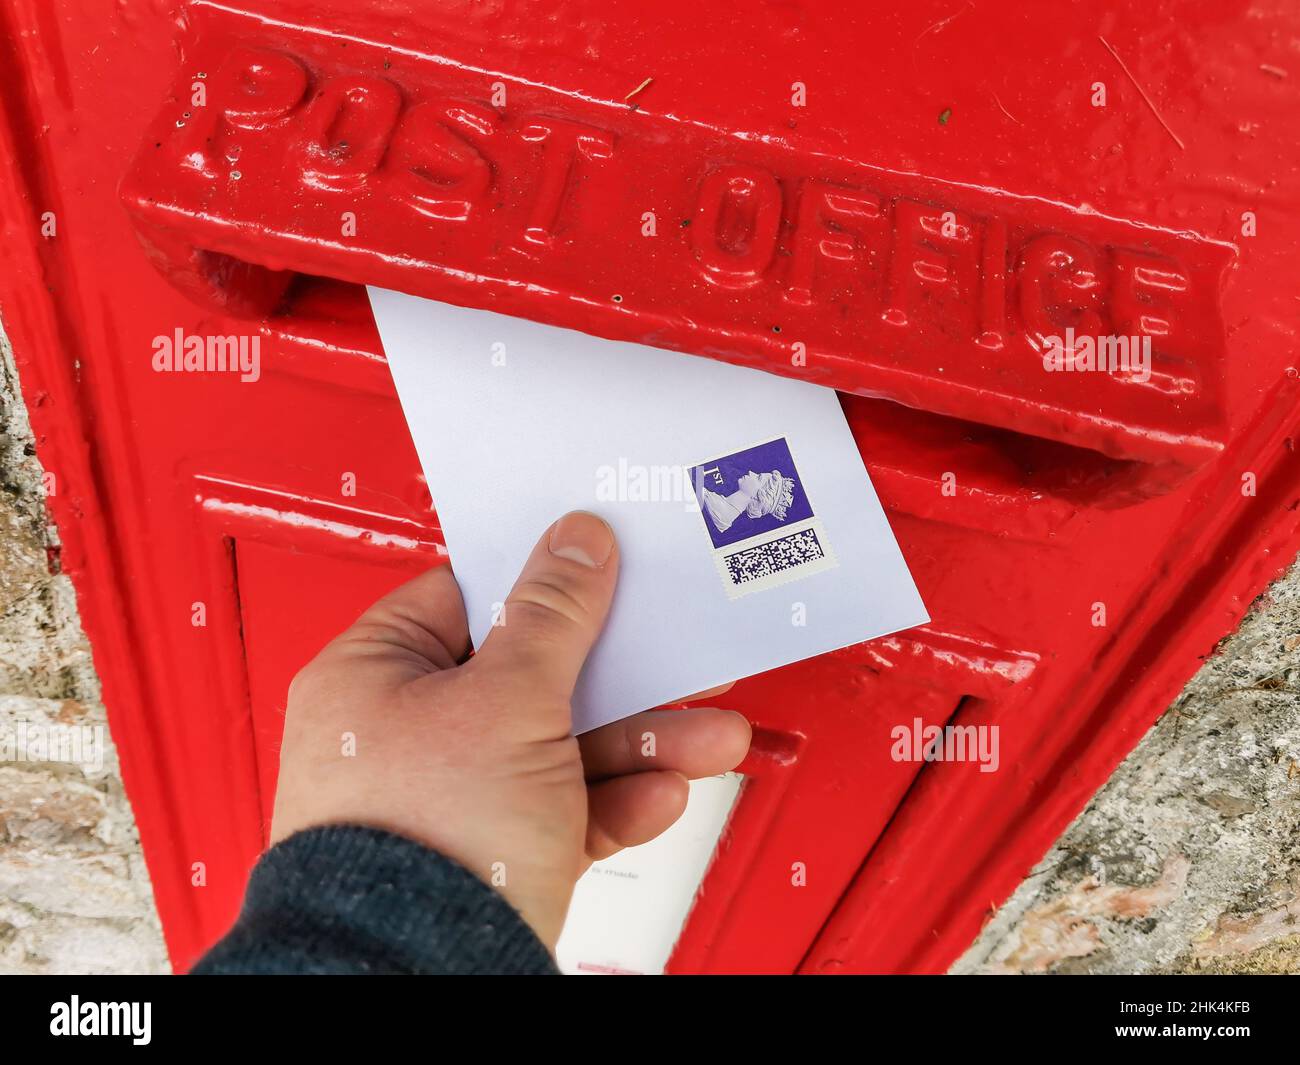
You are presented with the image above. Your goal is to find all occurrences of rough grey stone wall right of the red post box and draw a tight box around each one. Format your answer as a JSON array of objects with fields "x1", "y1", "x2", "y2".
[{"x1": 953, "y1": 563, "x2": 1300, "y2": 973}]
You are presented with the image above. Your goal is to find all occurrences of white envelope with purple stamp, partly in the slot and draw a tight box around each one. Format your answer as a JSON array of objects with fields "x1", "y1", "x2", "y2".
[{"x1": 369, "y1": 289, "x2": 928, "y2": 732}]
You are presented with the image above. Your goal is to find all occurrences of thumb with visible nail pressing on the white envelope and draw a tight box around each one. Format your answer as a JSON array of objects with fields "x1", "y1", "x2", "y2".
[{"x1": 473, "y1": 511, "x2": 619, "y2": 703}]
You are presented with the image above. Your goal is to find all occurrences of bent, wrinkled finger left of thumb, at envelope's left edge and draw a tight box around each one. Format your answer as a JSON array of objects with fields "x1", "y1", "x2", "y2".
[{"x1": 312, "y1": 564, "x2": 469, "y2": 672}]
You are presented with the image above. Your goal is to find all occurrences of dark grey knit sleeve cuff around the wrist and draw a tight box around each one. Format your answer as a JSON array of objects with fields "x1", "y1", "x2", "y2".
[{"x1": 192, "y1": 824, "x2": 556, "y2": 975}]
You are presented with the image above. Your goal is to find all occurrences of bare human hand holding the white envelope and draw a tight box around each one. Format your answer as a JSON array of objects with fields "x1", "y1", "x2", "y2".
[{"x1": 272, "y1": 512, "x2": 750, "y2": 951}]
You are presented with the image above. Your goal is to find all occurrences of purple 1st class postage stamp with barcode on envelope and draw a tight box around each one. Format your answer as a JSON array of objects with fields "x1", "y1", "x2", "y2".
[{"x1": 688, "y1": 437, "x2": 836, "y2": 598}]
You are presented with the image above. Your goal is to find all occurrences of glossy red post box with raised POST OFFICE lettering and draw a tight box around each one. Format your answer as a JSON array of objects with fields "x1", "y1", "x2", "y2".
[{"x1": 0, "y1": 0, "x2": 1300, "y2": 973}]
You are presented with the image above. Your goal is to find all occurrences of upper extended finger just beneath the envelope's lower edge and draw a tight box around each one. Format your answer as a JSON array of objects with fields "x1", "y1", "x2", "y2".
[{"x1": 577, "y1": 709, "x2": 751, "y2": 780}]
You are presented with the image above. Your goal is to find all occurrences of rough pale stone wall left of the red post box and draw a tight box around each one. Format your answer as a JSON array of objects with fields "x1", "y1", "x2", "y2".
[{"x1": 0, "y1": 333, "x2": 168, "y2": 974}]
